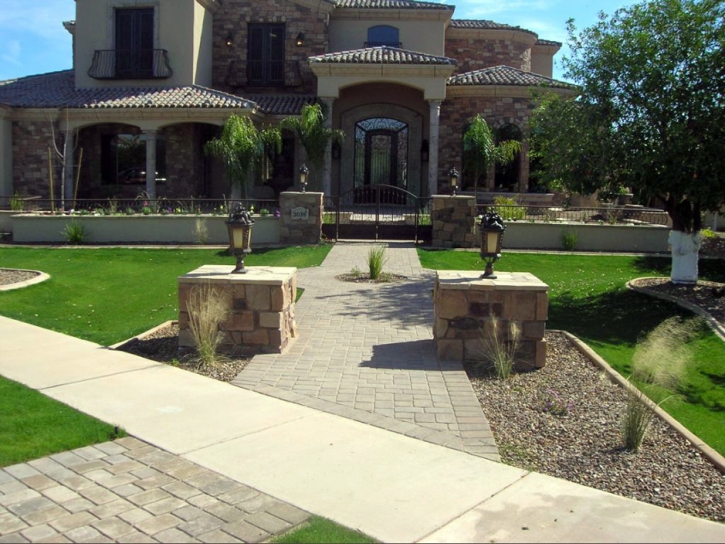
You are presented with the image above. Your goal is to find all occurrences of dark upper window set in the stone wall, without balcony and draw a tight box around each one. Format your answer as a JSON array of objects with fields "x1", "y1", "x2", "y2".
[{"x1": 247, "y1": 24, "x2": 285, "y2": 87}]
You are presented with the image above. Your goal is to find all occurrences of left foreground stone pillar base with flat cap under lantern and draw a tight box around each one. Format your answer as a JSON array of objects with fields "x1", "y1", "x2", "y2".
[{"x1": 179, "y1": 265, "x2": 297, "y2": 353}]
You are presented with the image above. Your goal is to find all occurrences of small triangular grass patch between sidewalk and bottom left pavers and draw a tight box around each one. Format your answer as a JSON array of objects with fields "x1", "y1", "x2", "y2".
[{"x1": 0, "y1": 377, "x2": 126, "y2": 467}]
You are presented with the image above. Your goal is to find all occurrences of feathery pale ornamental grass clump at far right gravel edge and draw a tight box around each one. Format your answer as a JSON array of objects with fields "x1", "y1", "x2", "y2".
[{"x1": 622, "y1": 317, "x2": 699, "y2": 452}]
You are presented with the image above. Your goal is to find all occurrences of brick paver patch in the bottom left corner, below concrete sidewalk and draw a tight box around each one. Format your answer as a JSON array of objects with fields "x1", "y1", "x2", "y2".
[{"x1": 0, "y1": 437, "x2": 310, "y2": 543}]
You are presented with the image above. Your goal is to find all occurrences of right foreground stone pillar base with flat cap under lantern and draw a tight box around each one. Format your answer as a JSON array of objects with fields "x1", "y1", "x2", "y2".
[{"x1": 433, "y1": 271, "x2": 549, "y2": 371}]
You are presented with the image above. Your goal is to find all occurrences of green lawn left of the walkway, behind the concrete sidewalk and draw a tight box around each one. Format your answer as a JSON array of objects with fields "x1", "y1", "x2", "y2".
[{"x1": 0, "y1": 245, "x2": 331, "y2": 345}]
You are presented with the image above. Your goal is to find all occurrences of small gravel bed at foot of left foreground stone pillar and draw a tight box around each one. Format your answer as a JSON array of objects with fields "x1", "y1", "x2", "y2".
[{"x1": 117, "y1": 323, "x2": 254, "y2": 382}]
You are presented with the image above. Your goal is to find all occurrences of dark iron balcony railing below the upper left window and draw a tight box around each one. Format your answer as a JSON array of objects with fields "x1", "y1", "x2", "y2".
[{"x1": 88, "y1": 49, "x2": 174, "y2": 79}]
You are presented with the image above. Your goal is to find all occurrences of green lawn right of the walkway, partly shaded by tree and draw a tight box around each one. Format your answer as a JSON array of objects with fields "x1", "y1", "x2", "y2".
[{"x1": 419, "y1": 249, "x2": 725, "y2": 455}]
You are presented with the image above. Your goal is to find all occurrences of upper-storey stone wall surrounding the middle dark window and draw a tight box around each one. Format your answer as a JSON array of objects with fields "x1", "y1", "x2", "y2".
[{"x1": 212, "y1": 0, "x2": 328, "y2": 94}]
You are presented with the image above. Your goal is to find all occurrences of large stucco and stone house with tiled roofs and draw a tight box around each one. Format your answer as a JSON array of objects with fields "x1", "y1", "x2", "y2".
[{"x1": 0, "y1": 0, "x2": 570, "y2": 206}]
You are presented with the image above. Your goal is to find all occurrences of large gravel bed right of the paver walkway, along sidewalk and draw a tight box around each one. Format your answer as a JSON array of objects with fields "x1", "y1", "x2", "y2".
[{"x1": 466, "y1": 332, "x2": 725, "y2": 523}]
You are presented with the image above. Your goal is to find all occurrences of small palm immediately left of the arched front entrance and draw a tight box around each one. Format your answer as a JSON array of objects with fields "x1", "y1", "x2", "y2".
[{"x1": 280, "y1": 104, "x2": 345, "y2": 193}]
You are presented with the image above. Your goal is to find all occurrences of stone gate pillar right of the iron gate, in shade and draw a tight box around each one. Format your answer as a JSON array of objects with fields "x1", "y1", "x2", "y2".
[{"x1": 430, "y1": 195, "x2": 476, "y2": 248}]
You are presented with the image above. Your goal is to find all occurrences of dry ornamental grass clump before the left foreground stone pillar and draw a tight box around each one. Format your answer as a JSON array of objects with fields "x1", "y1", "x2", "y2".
[{"x1": 186, "y1": 284, "x2": 231, "y2": 368}]
